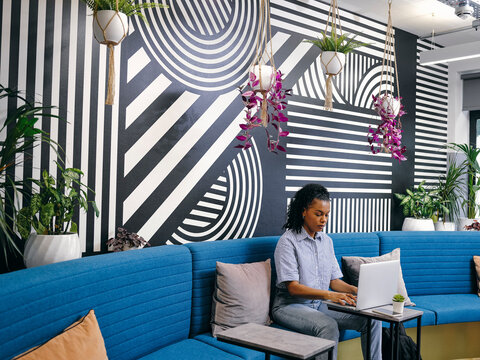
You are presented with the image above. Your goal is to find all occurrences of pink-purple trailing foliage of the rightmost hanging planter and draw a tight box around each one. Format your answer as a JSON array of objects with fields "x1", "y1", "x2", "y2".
[{"x1": 368, "y1": 95, "x2": 407, "y2": 162}]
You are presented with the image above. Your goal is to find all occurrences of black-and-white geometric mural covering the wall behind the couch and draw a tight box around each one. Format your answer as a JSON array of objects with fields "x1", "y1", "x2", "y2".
[{"x1": 0, "y1": 0, "x2": 447, "y2": 255}]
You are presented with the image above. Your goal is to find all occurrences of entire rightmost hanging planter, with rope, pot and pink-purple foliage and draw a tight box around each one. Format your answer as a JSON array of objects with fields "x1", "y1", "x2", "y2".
[{"x1": 367, "y1": 0, "x2": 407, "y2": 162}]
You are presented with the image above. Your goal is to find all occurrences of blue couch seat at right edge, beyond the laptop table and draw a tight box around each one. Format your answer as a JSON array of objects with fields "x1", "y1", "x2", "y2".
[{"x1": 413, "y1": 294, "x2": 480, "y2": 325}]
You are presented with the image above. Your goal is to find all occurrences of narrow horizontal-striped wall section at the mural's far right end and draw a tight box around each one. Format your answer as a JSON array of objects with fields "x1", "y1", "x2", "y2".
[{"x1": 414, "y1": 40, "x2": 448, "y2": 185}]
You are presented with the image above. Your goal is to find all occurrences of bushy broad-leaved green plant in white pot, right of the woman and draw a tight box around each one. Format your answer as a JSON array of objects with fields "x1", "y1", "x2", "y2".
[{"x1": 395, "y1": 180, "x2": 438, "y2": 231}]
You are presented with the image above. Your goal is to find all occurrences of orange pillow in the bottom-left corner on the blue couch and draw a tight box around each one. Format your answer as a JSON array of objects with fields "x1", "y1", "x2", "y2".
[{"x1": 12, "y1": 310, "x2": 108, "y2": 360}]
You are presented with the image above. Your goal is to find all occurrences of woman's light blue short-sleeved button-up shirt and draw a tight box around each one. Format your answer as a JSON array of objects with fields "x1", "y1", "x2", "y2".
[{"x1": 274, "y1": 228, "x2": 343, "y2": 306}]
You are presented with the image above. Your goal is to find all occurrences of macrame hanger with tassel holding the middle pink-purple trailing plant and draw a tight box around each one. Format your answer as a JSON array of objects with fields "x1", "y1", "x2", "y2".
[{"x1": 250, "y1": 0, "x2": 276, "y2": 127}]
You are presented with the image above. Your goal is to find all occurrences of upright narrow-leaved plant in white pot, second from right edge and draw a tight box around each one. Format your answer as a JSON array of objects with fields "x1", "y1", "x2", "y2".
[{"x1": 433, "y1": 161, "x2": 463, "y2": 231}]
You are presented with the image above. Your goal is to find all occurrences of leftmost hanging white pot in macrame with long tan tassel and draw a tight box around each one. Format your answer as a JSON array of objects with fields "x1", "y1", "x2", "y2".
[{"x1": 93, "y1": 0, "x2": 128, "y2": 105}]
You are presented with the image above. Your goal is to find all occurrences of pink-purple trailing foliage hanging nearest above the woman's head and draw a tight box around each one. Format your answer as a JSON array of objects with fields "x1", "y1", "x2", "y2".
[{"x1": 235, "y1": 70, "x2": 291, "y2": 153}]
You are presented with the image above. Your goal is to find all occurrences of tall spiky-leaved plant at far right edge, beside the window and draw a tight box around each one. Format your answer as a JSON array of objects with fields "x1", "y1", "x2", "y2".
[{"x1": 449, "y1": 143, "x2": 480, "y2": 231}]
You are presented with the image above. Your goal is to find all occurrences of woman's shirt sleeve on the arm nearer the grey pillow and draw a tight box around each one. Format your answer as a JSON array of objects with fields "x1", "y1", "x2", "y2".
[{"x1": 275, "y1": 237, "x2": 300, "y2": 287}]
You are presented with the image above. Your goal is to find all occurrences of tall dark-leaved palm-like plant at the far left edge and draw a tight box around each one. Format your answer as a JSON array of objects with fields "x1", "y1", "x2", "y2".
[{"x1": 0, "y1": 85, "x2": 58, "y2": 270}]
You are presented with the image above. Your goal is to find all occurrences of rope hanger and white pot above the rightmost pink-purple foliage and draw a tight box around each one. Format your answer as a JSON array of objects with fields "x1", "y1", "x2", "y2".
[{"x1": 379, "y1": 0, "x2": 402, "y2": 121}]
